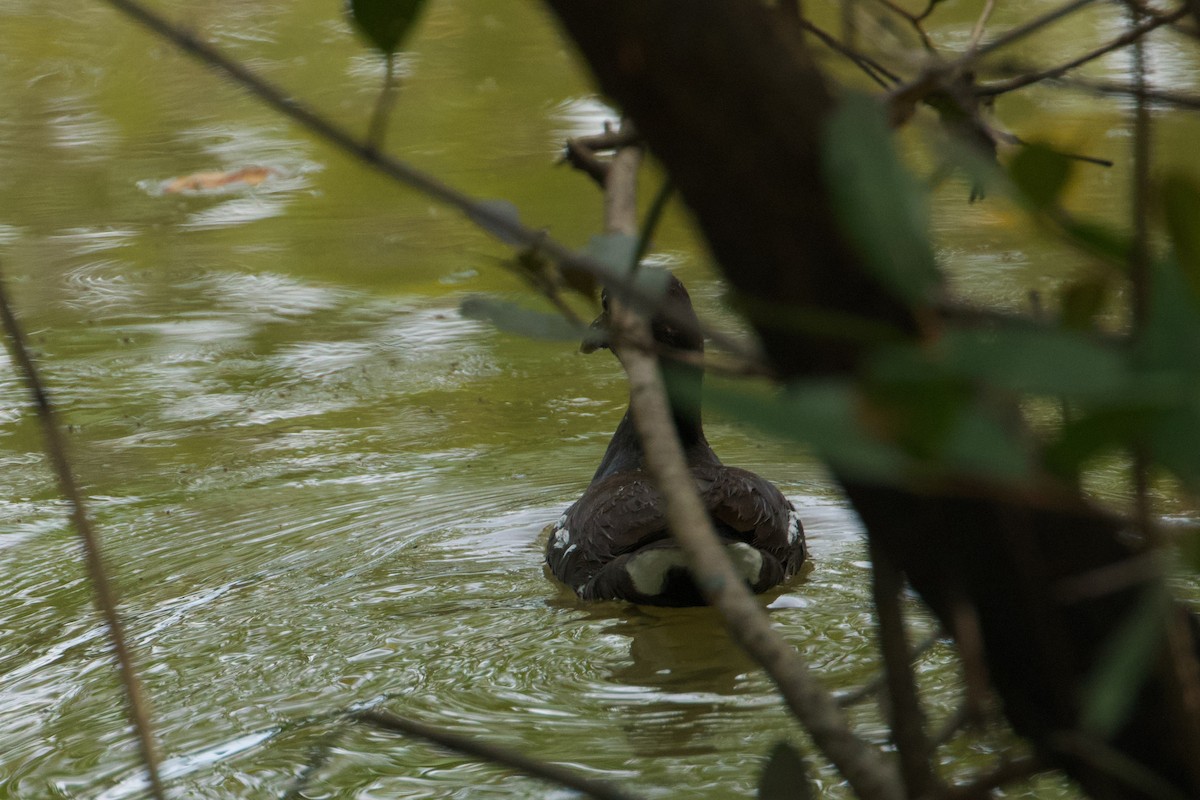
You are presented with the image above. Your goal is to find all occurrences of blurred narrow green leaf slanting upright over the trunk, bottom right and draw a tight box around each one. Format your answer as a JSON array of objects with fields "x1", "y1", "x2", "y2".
[{"x1": 1080, "y1": 587, "x2": 1169, "y2": 740}]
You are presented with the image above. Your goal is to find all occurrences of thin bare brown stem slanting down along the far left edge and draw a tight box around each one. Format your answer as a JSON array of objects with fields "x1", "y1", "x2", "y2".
[{"x1": 0, "y1": 271, "x2": 166, "y2": 800}]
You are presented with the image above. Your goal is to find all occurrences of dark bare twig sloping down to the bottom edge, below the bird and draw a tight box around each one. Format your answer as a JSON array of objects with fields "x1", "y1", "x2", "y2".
[{"x1": 350, "y1": 709, "x2": 635, "y2": 800}]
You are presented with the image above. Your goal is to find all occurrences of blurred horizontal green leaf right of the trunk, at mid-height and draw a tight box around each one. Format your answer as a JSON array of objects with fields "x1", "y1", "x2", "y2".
[{"x1": 938, "y1": 327, "x2": 1129, "y2": 399}]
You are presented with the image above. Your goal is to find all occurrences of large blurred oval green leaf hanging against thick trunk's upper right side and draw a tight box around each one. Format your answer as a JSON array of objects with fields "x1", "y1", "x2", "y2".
[{"x1": 821, "y1": 94, "x2": 941, "y2": 306}]
